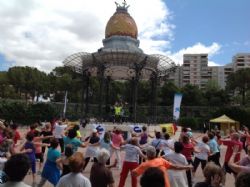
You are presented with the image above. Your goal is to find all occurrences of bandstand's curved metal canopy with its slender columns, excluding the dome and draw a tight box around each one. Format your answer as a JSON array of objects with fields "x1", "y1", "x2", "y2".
[{"x1": 63, "y1": 49, "x2": 176, "y2": 123}]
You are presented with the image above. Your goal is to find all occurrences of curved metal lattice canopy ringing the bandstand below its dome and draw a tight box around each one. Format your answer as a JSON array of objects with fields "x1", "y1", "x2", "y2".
[{"x1": 63, "y1": 50, "x2": 176, "y2": 80}]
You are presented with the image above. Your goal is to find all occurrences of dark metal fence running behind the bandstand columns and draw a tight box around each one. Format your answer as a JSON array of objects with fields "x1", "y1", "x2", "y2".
[{"x1": 52, "y1": 103, "x2": 218, "y2": 124}]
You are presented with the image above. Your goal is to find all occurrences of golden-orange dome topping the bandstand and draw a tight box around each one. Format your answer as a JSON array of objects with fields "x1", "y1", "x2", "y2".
[{"x1": 105, "y1": 8, "x2": 138, "y2": 39}]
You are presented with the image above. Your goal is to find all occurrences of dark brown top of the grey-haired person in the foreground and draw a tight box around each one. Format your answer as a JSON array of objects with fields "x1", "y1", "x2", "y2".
[{"x1": 90, "y1": 163, "x2": 114, "y2": 187}]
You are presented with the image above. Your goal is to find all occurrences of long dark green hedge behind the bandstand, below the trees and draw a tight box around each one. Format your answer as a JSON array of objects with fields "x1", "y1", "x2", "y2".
[{"x1": 0, "y1": 100, "x2": 250, "y2": 129}]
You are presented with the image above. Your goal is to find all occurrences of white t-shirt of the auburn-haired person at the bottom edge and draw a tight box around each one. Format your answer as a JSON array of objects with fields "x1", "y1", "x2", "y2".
[{"x1": 56, "y1": 173, "x2": 91, "y2": 187}]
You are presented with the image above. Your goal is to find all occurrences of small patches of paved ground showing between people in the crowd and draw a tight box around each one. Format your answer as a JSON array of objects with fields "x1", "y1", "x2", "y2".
[{"x1": 18, "y1": 125, "x2": 237, "y2": 187}]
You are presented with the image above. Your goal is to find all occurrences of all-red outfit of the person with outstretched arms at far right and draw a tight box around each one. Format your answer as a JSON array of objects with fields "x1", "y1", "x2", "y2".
[{"x1": 221, "y1": 140, "x2": 243, "y2": 162}]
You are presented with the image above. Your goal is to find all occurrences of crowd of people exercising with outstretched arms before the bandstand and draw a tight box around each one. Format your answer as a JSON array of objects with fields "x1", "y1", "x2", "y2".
[{"x1": 0, "y1": 119, "x2": 250, "y2": 187}]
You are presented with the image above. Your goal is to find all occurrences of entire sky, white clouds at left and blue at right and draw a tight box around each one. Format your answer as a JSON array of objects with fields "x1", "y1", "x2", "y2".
[{"x1": 0, "y1": 0, "x2": 250, "y2": 72}]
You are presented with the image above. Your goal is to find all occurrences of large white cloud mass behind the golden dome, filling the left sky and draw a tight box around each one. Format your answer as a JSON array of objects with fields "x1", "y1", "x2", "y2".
[{"x1": 0, "y1": 0, "x2": 174, "y2": 72}]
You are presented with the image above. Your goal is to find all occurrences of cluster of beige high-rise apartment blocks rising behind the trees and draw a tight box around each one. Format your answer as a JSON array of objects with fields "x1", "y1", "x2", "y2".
[{"x1": 168, "y1": 53, "x2": 250, "y2": 89}]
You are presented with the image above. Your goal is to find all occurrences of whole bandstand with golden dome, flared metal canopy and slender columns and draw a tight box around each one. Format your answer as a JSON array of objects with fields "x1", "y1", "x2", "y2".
[{"x1": 63, "y1": 1, "x2": 176, "y2": 122}]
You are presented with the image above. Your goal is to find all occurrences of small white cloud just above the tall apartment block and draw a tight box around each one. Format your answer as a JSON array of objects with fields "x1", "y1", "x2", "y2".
[{"x1": 167, "y1": 42, "x2": 221, "y2": 66}]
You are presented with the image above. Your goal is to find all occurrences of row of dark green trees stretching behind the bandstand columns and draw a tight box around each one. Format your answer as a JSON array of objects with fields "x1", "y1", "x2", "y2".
[{"x1": 0, "y1": 66, "x2": 250, "y2": 106}]
